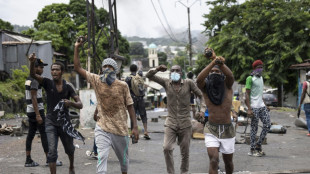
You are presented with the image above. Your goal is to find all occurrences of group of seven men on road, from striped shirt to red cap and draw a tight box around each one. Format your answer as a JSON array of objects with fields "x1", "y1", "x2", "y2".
[{"x1": 25, "y1": 41, "x2": 270, "y2": 174}]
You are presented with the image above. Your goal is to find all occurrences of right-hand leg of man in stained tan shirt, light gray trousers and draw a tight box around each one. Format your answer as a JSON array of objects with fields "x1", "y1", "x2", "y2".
[{"x1": 111, "y1": 134, "x2": 129, "y2": 174}]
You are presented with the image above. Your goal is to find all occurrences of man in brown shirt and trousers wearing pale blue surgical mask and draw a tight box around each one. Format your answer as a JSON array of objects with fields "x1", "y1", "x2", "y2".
[{"x1": 146, "y1": 65, "x2": 206, "y2": 174}]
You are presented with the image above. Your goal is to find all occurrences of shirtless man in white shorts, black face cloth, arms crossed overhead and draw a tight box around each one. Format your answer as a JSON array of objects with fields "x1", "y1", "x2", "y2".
[{"x1": 196, "y1": 48, "x2": 235, "y2": 174}]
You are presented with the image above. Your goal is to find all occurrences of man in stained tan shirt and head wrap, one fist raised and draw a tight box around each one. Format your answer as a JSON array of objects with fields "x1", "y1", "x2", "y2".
[{"x1": 74, "y1": 41, "x2": 139, "y2": 174}]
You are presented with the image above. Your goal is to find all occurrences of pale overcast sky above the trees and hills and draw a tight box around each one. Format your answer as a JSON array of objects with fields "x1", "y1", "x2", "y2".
[{"x1": 0, "y1": 0, "x2": 213, "y2": 37}]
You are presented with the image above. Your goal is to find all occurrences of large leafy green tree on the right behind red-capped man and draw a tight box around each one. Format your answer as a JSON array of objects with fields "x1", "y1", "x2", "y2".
[{"x1": 204, "y1": 0, "x2": 310, "y2": 106}]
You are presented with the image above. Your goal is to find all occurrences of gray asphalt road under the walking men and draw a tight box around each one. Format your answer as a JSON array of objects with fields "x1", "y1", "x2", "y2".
[{"x1": 0, "y1": 110, "x2": 310, "y2": 174}]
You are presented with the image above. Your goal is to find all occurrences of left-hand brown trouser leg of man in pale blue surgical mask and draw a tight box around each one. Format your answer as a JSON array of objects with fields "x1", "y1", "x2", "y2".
[{"x1": 163, "y1": 127, "x2": 176, "y2": 174}]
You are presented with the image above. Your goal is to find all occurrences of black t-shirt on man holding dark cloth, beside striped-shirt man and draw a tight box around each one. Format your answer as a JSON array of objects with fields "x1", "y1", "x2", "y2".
[{"x1": 42, "y1": 78, "x2": 77, "y2": 126}]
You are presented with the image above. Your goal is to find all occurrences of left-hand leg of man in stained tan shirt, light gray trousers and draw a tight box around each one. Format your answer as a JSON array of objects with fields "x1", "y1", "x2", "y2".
[{"x1": 95, "y1": 124, "x2": 112, "y2": 174}]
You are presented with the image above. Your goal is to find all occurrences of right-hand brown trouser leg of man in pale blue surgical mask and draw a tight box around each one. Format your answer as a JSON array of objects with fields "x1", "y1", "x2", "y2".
[{"x1": 178, "y1": 127, "x2": 192, "y2": 174}]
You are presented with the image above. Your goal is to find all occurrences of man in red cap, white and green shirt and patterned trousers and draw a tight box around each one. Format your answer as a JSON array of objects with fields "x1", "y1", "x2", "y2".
[{"x1": 245, "y1": 60, "x2": 271, "y2": 157}]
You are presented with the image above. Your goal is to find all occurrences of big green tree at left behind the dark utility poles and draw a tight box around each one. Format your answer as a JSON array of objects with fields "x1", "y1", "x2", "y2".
[{"x1": 23, "y1": 0, "x2": 129, "y2": 71}]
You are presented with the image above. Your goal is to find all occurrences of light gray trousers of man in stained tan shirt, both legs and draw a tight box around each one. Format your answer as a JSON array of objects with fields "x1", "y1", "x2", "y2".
[{"x1": 95, "y1": 124, "x2": 129, "y2": 174}]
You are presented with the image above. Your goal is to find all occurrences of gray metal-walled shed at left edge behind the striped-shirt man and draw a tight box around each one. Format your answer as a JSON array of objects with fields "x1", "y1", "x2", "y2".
[{"x1": 0, "y1": 30, "x2": 53, "y2": 80}]
